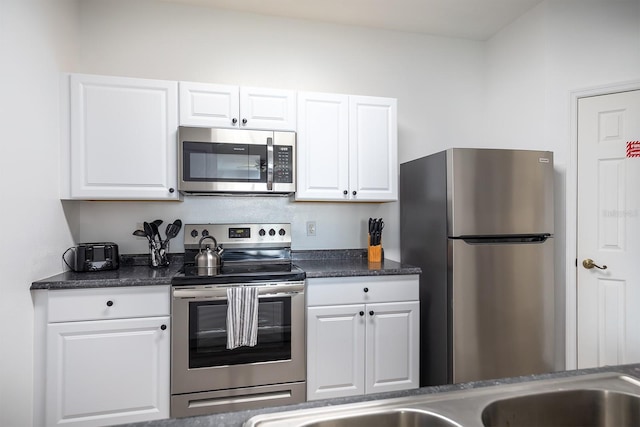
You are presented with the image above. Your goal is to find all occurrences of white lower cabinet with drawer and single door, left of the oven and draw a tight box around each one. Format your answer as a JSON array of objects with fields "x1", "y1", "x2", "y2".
[{"x1": 34, "y1": 286, "x2": 170, "y2": 427}]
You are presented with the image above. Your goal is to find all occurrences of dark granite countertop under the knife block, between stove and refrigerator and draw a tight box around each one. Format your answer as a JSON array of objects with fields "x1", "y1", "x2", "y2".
[{"x1": 293, "y1": 249, "x2": 422, "y2": 279}]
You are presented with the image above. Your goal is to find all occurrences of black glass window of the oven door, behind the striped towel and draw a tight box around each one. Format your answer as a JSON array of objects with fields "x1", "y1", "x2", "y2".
[{"x1": 189, "y1": 297, "x2": 291, "y2": 369}]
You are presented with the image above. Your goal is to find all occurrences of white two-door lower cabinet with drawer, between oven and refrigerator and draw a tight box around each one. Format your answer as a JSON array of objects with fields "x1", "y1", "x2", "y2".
[{"x1": 307, "y1": 275, "x2": 420, "y2": 400}]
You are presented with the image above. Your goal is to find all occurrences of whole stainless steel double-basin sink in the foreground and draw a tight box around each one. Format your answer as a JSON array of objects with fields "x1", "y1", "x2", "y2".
[{"x1": 245, "y1": 373, "x2": 640, "y2": 427}]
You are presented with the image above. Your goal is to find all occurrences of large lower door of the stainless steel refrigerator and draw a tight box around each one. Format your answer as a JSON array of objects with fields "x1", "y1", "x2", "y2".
[{"x1": 449, "y1": 239, "x2": 555, "y2": 383}]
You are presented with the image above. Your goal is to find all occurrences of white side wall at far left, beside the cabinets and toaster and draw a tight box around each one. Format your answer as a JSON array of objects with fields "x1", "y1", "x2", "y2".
[{"x1": 0, "y1": 0, "x2": 77, "y2": 427}]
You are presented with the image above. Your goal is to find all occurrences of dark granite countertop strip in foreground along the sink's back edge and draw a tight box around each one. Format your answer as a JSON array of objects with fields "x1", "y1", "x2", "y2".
[{"x1": 117, "y1": 364, "x2": 640, "y2": 427}]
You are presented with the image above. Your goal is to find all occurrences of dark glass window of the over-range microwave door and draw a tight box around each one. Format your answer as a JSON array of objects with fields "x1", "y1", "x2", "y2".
[{"x1": 183, "y1": 141, "x2": 267, "y2": 182}]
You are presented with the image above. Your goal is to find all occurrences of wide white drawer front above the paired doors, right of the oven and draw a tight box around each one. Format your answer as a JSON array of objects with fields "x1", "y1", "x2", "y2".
[{"x1": 306, "y1": 275, "x2": 419, "y2": 307}]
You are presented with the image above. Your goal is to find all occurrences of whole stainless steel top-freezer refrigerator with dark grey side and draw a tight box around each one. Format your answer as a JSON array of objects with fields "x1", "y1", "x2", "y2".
[{"x1": 400, "y1": 148, "x2": 555, "y2": 386}]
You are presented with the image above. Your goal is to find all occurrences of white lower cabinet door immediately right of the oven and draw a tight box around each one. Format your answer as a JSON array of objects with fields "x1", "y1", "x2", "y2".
[{"x1": 307, "y1": 304, "x2": 365, "y2": 400}]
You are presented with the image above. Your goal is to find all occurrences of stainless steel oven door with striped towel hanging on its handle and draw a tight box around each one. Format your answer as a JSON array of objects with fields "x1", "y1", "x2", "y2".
[{"x1": 171, "y1": 282, "x2": 306, "y2": 394}]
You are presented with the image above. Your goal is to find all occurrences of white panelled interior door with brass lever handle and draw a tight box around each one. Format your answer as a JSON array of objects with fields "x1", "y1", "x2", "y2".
[{"x1": 577, "y1": 90, "x2": 640, "y2": 368}]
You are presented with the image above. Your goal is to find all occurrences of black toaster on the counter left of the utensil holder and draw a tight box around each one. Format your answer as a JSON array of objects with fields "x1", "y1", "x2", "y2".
[{"x1": 62, "y1": 242, "x2": 120, "y2": 272}]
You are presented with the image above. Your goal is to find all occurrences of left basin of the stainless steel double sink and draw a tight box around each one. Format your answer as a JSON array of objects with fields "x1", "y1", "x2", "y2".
[{"x1": 302, "y1": 408, "x2": 461, "y2": 427}]
